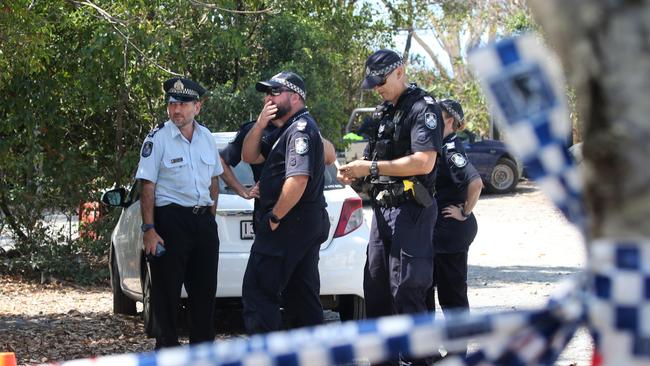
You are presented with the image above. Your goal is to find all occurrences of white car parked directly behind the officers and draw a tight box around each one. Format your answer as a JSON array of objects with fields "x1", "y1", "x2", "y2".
[{"x1": 102, "y1": 132, "x2": 369, "y2": 334}]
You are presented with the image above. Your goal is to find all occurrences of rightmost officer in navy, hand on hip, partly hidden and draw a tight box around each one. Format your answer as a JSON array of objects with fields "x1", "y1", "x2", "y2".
[{"x1": 433, "y1": 99, "x2": 483, "y2": 312}]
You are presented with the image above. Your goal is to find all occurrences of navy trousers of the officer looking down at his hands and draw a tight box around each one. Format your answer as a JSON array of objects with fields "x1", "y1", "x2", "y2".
[{"x1": 363, "y1": 201, "x2": 438, "y2": 365}]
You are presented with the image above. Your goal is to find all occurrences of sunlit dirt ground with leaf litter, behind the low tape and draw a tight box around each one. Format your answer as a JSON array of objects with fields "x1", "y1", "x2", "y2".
[{"x1": 0, "y1": 181, "x2": 591, "y2": 366}]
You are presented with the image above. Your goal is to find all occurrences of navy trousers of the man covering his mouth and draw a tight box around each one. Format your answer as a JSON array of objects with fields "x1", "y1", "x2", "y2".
[{"x1": 242, "y1": 208, "x2": 329, "y2": 334}]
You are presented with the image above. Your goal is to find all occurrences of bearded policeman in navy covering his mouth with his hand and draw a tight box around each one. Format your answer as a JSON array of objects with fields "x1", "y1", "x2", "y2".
[{"x1": 242, "y1": 71, "x2": 329, "y2": 333}]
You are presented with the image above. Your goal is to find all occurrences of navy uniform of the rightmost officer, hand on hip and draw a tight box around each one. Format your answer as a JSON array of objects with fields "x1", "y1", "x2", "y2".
[{"x1": 431, "y1": 128, "x2": 480, "y2": 310}]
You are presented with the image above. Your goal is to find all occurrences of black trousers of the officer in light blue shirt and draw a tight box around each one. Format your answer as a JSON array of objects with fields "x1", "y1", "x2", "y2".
[{"x1": 150, "y1": 206, "x2": 219, "y2": 348}]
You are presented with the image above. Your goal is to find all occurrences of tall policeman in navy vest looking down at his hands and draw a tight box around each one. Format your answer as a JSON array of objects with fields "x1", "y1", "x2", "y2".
[{"x1": 338, "y1": 50, "x2": 442, "y2": 363}]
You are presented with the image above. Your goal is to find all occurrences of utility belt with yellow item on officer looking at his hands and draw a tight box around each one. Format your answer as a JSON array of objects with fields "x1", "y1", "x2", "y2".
[{"x1": 369, "y1": 176, "x2": 435, "y2": 208}]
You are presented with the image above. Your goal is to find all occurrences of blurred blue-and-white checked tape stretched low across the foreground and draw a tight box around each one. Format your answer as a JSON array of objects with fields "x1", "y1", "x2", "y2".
[{"x1": 43, "y1": 280, "x2": 583, "y2": 366}]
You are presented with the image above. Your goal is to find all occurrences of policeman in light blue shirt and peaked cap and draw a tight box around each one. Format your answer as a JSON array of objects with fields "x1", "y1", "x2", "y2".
[{"x1": 136, "y1": 78, "x2": 223, "y2": 349}]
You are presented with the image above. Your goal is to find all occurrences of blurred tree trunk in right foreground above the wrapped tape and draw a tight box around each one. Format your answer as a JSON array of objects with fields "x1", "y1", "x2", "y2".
[{"x1": 529, "y1": 0, "x2": 650, "y2": 239}]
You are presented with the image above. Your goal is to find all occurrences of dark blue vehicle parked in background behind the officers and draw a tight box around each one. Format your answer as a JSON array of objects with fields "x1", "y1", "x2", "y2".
[{"x1": 339, "y1": 108, "x2": 523, "y2": 194}]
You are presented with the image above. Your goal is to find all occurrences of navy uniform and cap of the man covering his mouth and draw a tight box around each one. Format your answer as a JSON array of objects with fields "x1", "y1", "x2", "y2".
[{"x1": 242, "y1": 73, "x2": 330, "y2": 333}]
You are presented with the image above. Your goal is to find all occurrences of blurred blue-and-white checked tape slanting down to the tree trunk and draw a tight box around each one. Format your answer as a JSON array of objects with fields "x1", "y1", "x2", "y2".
[{"x1": 469, "y1": 35, "x2": 585, "y2": 229}]
